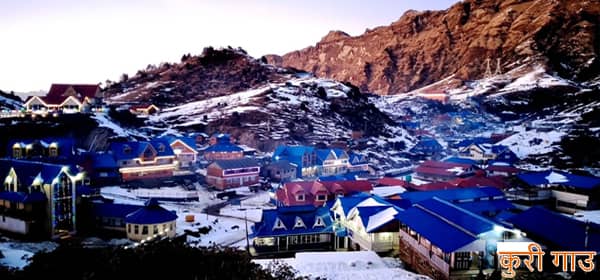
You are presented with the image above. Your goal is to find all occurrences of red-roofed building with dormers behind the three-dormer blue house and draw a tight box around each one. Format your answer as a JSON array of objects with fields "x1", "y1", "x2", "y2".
[{"x1": 275, "y1": 180, "x2": 373, "y2": 206}]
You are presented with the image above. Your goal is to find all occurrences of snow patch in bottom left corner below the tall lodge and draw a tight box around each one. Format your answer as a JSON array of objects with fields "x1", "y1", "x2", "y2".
[{"x1": 0, "y1": 240, "x2": 58, "y2": 269}]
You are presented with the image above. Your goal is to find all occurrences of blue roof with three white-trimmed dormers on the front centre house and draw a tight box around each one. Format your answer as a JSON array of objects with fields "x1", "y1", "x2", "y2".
[{"x1": 253, "y1": 206, "x2": 333, "y2": 237}]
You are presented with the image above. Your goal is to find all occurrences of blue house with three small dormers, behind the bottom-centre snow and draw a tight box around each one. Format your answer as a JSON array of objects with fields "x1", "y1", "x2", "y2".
[{"x1": 250, "y1": 205, "x2": 334, "y2": 255}]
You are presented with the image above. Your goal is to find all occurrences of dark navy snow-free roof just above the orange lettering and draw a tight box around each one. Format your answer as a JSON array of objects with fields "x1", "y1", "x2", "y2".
[{"x1": 508, "y1": 206, "x2": 600, "y2": 252}]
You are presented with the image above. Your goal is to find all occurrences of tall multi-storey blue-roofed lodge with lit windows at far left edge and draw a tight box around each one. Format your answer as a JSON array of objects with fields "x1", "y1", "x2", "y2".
[{"x1": 0, "y1": 159, "x2": 85, "y2": 238}]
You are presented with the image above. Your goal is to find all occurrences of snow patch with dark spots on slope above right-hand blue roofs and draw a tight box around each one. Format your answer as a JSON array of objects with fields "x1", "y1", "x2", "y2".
[{"x1": 497, "y1": 130, "x2": 565, "y2": 159}]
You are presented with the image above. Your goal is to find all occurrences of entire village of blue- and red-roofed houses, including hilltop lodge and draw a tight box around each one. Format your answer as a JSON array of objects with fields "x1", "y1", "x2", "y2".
[{"x1": 0, "y1": 84, "x2": 600, "y2": 279}]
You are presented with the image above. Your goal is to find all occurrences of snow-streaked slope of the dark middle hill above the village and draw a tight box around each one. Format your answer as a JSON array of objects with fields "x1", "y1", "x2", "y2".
[{"x1": 149, "y1": 76, "x2": 410, "y2": 149}]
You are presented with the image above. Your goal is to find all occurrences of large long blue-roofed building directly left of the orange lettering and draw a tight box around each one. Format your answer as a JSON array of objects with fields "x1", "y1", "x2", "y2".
[{"x1": 396, "y1": 197, "x2": 521, "y2": 279}]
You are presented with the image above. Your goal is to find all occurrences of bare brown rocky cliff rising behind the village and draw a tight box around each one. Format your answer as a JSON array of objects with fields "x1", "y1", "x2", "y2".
[{"x1": 266, "y1": 0, "x2": 600, "y2": 94}]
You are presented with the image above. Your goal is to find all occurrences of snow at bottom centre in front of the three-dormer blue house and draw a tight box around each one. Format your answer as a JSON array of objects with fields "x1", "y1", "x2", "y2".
[{"x1": 253, "y1": 251, "x2": 430, "y2": 280}]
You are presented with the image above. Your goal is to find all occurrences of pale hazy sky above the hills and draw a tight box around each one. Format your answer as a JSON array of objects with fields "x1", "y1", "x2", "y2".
[{"x1": 0, "y1": 0, "x2": 457, "y2": 92}]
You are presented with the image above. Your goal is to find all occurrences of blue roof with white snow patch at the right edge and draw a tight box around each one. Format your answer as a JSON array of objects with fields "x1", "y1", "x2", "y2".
[{"x1": 517, "y1": 170, "x2": 600, "y2": 190}]
